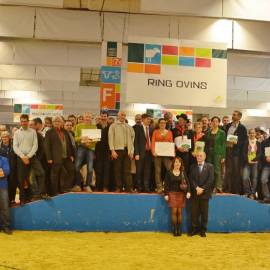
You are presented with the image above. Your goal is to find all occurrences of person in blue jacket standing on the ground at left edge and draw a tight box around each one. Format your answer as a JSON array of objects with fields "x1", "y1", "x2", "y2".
[{"x1": 0, "y1": 153, "x2": 12, "y2": 234}]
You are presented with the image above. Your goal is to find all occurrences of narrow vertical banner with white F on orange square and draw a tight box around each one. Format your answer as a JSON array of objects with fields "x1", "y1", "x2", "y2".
[{"x1": 100, "y1": 41, "x2": 122, "y2": 110}]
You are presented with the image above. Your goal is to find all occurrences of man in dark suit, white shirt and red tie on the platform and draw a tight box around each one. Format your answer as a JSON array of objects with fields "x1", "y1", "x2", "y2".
[{"x1": 134, "y1": 113, "x2": 152, "y2": 192}]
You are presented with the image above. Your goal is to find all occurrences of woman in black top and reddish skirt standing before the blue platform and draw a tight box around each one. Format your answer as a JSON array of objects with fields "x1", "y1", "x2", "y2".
[{"x1": 164, "y1": 157, "x2": 190, "y2": 236}]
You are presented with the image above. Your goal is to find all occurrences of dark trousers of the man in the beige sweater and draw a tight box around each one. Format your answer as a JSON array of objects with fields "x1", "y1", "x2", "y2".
[{"x1": 113, "y1": 149, "x2": 132, "y2": 192}]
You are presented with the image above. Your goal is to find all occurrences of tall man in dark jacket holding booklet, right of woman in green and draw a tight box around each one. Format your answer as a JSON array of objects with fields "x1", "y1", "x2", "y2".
[{"x1": 223, "y1": 111, "x2": 248, "y2": 194}]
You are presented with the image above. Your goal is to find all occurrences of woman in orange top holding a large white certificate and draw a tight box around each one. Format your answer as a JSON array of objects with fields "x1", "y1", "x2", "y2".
[{"x1": 151, "y1": 118, "x2": 175, "y2": 193}]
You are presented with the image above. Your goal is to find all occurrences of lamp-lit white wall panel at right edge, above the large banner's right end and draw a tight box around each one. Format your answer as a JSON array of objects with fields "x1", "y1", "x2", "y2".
[{"x1": 233, "y1": 21, "x2": 270, "y2": 52}]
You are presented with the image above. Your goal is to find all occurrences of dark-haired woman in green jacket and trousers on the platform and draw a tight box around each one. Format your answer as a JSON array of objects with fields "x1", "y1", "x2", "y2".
[{"x1": 205, "y1": 116, "x2": 226, "y2": 193}]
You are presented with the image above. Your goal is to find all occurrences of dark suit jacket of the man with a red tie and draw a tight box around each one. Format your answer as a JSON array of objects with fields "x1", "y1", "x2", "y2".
[{"x1": 133, "y1": 125, "x2": 153, "y2": 157}]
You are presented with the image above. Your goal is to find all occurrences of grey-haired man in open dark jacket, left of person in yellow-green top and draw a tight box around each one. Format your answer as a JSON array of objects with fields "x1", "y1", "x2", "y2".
[{"x1": 44, "y1": 116, "x2": 75, "y2": 196}]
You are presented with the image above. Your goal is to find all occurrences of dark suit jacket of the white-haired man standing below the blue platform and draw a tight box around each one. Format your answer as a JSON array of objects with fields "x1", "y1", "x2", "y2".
[{"x1": 189, "y1": 162, "x2": 214, "y2": 199}]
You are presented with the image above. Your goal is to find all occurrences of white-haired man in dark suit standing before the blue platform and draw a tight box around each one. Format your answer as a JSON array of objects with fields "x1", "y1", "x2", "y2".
[{"x1": 189, "y1": 152, "x2": 214, "y2": 237}]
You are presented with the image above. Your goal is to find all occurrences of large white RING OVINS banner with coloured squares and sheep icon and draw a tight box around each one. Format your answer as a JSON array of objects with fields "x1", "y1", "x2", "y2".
[{"x1": 127, "y1": 38, "x2": 227, "y2": 107}]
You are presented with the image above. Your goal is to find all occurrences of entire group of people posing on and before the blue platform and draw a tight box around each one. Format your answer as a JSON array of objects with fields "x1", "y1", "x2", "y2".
[{"x1": 0, "y1": 108, "x2": 270, "y2": 236}]
